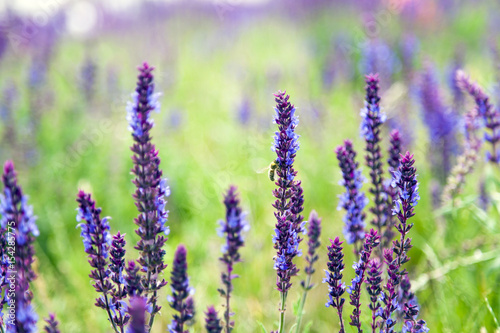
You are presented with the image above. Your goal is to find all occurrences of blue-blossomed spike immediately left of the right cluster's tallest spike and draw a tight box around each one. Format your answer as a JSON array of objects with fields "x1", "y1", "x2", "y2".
[{"x1": 335, "y1": 140, "x2": 368, "y2": 250}]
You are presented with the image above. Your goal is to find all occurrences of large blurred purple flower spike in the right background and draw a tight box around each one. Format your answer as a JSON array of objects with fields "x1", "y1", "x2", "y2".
[{"x1": 419, "y1": 64, "x2": 458, "y2": 184}]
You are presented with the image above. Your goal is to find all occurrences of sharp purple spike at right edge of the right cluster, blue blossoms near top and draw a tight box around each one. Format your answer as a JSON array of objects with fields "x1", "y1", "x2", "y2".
[{"x1": 381, "y1": 152, "x2": 420, "y2": 333}]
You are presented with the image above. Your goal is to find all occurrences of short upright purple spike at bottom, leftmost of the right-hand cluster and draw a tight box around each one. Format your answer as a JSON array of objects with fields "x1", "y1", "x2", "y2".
[{"x1": 323, "y1": 237, "x2": 345, "y2": 333}]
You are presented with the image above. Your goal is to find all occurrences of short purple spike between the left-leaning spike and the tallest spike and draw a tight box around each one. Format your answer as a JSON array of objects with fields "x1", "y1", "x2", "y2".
[{"x1": 109, "y1": 232, "x2": 130, "y2": 328}]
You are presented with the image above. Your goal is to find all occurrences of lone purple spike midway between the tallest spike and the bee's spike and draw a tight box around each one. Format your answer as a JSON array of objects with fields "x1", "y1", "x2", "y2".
[{"x1": 218, "y1": 186, "x2": 248, "y2": 333}]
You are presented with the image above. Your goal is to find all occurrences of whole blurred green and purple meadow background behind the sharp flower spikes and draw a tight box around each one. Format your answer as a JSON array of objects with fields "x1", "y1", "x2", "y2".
[{"x1": 0, "y1": 0, "x2": 500, "y2": 333}]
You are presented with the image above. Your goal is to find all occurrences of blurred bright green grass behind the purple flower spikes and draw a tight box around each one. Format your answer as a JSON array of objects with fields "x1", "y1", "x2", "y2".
[{"x1": 0, "y1": 1, "x2": 500, "y2": 333}]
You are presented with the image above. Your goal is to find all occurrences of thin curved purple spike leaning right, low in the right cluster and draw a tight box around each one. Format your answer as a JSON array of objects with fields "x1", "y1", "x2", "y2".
[{"x1": 347, "y1": 229, "x2": 380, "y2": 332}]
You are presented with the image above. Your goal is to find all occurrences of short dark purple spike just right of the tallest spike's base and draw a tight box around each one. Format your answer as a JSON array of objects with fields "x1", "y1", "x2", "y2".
[{"x1": 168, "y1": 245, "x2": 192, "y2": 333}]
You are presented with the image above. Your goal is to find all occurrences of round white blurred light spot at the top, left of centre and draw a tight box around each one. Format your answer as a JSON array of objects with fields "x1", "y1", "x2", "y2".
[{"x1": 66, "y1": 1, "x2": 98, "y2": 37}]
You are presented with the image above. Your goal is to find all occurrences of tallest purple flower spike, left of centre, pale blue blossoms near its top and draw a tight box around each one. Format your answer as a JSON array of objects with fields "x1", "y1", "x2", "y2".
[{"x1": 127, "y1": 63, "x2": 170, "y2": 327}]
